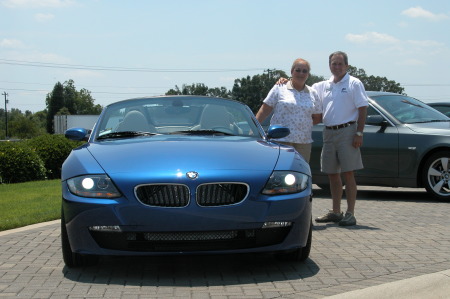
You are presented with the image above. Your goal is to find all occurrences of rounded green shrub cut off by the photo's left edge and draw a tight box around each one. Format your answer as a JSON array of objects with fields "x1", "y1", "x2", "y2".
[{"x1": 0, "y1": 142, "x2": 46, "y2": 183}]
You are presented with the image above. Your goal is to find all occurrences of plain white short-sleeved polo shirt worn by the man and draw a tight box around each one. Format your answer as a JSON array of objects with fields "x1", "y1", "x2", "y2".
[{"x1": 312, "y1": 73, "x2": 368, "y2": 126}]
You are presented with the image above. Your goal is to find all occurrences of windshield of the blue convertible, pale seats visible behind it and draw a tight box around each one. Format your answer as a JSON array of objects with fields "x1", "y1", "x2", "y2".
[{"x1": 94, "y1": 96, "x2": 261, "y2": 139}]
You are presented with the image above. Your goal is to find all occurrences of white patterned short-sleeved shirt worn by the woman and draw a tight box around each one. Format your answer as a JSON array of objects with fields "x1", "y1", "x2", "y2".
[{"x1": 264, "y1": 82, "x2": 322, "y2": 144}]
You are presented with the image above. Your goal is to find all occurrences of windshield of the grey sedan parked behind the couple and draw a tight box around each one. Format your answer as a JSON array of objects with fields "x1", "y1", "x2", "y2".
[{"x1": 371, "y1": 95, "x2": 450, "y2": 124}]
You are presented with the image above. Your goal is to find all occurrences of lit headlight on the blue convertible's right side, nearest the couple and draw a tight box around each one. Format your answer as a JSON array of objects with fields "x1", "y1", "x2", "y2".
[{"x1": 262, "y1": 171, "x2": 309, "y2": 195}]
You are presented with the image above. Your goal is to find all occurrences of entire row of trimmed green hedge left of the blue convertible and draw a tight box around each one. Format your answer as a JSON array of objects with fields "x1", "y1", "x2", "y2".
[{"x1": 0, "y1": 135, "x2": 83, "y2": 183}]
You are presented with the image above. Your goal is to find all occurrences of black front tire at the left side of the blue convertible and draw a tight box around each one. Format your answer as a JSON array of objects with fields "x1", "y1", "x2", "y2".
[{"x1": 61, "y1": 211, "x2": 98, "y2": 268}]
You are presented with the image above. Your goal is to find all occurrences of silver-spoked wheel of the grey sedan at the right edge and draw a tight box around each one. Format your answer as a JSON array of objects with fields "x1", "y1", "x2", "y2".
[{"x1": 422, "y1": 151, "x2": 450, "y2": 200}]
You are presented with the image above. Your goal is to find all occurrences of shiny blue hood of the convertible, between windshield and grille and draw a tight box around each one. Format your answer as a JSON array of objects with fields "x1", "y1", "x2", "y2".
[{"x1": 87, "y1": 137, "x2": 280, "y2": 174}]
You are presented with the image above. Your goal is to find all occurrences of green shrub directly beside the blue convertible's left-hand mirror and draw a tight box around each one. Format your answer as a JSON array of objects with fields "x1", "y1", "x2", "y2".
[{"x1": 26, "y1": 135, "x2": 83, "y2": 179}]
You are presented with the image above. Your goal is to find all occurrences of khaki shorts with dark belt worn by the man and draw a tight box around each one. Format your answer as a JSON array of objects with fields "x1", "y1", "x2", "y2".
[{"x1": 320, "y1": 124, "x2": 364, "y2": 174}]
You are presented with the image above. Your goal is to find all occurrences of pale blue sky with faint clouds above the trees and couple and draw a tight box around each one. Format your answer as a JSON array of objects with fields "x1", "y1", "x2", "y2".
[{"x1": 0, "y1": 0, "x2": 450, "y2": 112}]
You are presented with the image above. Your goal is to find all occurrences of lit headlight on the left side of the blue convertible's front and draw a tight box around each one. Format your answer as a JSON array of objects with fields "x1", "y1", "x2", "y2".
[{"x1": 67, "y1": 174, "x2": 121, "y2": 198}]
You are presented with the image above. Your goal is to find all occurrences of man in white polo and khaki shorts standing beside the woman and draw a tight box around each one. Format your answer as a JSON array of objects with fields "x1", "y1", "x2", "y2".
[{"x1": 312, "y1": 51, "x2": 368, "y2": 226}]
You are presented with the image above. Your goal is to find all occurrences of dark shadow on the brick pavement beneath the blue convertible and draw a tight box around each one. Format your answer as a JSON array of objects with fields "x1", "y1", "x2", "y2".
[{"x1": 62, "y1": 254, "x2": 319, "y2": 287}]
